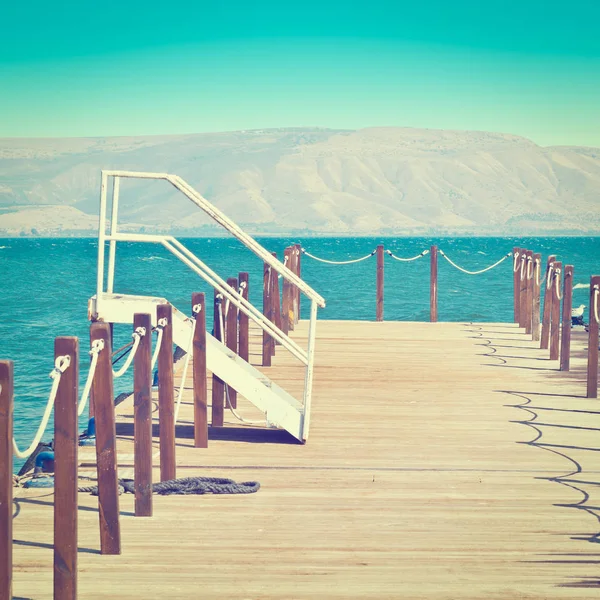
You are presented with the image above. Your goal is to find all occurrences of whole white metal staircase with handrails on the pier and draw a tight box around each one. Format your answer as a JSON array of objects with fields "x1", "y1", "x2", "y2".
[{"x1": 89, "y1": 171, "x2": 325, "y2": 441}]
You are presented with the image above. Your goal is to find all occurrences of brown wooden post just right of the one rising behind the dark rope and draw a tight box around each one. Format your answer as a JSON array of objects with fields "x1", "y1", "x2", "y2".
[{"x1": 192, "y1": 292, "x2": 211, "y2": 448}]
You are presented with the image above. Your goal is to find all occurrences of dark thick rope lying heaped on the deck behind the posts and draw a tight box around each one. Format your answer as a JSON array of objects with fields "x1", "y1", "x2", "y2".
[{"x1": 78, "y1": 477, "x2": 260, "y2": 496}]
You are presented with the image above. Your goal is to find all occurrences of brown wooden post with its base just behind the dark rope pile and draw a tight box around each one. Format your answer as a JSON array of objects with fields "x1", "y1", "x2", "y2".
[{"x1": 156, "y1": 304, "x2": 176, "y2": 481}]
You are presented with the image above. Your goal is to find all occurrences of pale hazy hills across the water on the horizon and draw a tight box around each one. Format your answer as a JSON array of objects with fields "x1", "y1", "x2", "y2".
[{"x1": 0, "y1": 128, "x2": 600, "y2": 235}]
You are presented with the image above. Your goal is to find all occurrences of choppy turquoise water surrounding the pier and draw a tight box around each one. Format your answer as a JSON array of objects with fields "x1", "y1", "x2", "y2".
[{"x1": 0, "y1": 237, "x2": 600, "y2": 467}]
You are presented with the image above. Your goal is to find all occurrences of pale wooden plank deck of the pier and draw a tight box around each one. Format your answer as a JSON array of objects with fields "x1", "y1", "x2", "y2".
[{"x1": 13, "y1": 321, "x2": 600, "y2": 600}]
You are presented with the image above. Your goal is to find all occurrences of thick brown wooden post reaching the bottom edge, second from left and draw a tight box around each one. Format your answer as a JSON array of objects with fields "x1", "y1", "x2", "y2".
[{"x1": 54, "y1": 337, "x2": 79, "y2": 600}]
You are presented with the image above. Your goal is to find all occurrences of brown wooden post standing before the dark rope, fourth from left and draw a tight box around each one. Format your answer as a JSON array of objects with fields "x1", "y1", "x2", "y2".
[{"x1": 133, "y1": 313, "x2": 152, "y2": 517}]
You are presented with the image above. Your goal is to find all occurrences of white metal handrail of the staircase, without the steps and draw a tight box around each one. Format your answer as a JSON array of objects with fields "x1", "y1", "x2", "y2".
[{"x1": 96, "y1": 170, "x2": 325, "y2": 438}]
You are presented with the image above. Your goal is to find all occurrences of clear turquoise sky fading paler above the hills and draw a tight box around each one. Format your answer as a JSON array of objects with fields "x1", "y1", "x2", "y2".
[{"x1": 0, "y1": 0, "x2": 600, "y2": 146}]
